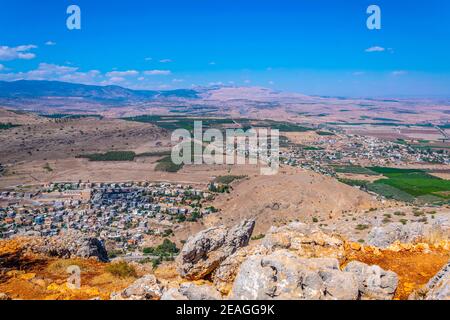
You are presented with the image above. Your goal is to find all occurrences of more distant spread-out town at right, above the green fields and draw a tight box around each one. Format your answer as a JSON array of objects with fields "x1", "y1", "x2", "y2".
[{"x1": 280, "y1": 134, "x2": 450, "y2": 176}]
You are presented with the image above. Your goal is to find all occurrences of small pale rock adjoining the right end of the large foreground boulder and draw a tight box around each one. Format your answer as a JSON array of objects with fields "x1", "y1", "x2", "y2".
[{"x1": 344, "y1": 261, "x2": 398, "y2": 300}]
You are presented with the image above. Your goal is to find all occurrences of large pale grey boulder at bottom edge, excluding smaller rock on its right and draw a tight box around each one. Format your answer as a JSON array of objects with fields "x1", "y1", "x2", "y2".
[{"x1": 230, "y1": 250, "x2": 359, "y2": 300}]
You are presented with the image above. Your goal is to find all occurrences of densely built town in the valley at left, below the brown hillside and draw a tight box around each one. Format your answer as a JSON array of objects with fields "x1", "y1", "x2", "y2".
[{"x1": 0, "y1": 183, "x2": 214, "y2": 251}]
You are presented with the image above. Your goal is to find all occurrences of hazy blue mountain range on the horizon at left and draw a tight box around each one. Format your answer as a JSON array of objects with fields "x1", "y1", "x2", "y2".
[{"x1": 0, "y1": 80, "x2": 199, "y2": 102}]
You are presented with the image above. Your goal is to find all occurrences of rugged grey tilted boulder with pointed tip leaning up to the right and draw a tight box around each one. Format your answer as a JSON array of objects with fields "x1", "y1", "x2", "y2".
[{"x1": 177, "y1": 220, "x2": 255, "y2": 280}]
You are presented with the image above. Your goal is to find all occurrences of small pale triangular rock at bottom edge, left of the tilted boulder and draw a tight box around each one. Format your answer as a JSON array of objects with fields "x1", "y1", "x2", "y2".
[{"x1": 111, "y1": 274, "x2": 162, "y2": 300}]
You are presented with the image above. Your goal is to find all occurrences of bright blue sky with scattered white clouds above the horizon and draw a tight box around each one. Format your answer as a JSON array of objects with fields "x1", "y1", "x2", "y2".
[{"x1": 0, "y1": 0, "x2": 450, "y2": 96}]
